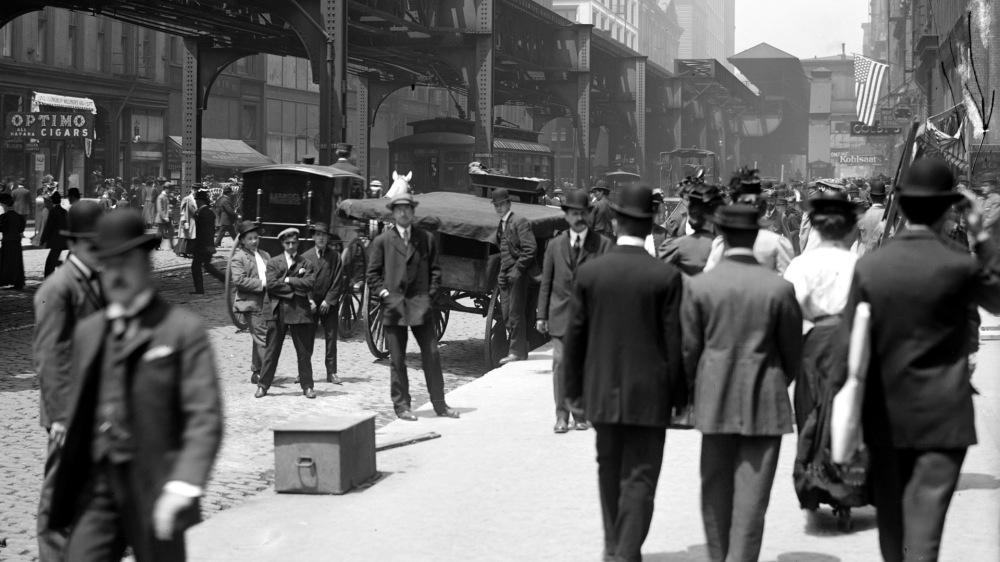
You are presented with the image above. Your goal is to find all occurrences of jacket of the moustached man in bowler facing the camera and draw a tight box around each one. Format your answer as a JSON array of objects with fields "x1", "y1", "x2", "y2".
[{"x1": 536, "y1": 230, "x2": 614, "y2": 338}]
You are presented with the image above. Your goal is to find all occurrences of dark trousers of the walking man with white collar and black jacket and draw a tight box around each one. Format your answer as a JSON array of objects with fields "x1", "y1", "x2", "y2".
[{"x1": 594, "y1": 423, "x2": 667, "y2": 562}]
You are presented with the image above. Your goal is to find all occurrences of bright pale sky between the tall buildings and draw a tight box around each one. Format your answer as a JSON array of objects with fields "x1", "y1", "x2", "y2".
[{"x1": 736, "y1": 0, "x2": 868, "y2": 59}]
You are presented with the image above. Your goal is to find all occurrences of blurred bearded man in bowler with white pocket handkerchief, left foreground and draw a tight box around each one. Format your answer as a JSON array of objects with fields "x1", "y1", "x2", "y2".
[{"x1": 49, "y1": 211, "x2": 222, "y2": 561}]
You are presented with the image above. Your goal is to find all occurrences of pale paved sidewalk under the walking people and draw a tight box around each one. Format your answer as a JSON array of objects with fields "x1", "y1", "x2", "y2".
[{"x1": 187, "y1": 343, "x2": 1000, "y2": 562}]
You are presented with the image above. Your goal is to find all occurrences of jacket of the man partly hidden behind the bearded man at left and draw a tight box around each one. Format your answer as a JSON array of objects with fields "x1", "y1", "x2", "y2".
[{"x1": 32, "y1": 259, "x2": 104, "y2": 428}]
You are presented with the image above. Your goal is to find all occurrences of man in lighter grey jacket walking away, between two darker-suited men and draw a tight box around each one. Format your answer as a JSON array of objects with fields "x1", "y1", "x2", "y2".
[{"x1": 682, "y1": 205, "x2": 802, "y2": 562}]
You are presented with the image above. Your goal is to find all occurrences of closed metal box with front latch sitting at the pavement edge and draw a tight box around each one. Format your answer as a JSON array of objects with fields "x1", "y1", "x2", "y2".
[{"x1": 274, "y1": 415, "x2": 375, "y2": 494}]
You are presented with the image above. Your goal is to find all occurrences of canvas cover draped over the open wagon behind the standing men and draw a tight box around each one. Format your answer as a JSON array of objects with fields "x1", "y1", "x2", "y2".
[{"x1": 339, "y1": 192, "x2": 566, "y2": 243}]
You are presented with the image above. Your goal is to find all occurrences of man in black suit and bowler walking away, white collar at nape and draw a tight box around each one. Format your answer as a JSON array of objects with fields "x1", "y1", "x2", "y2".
[{"x1": 563, "y1": 183, "x2": 687, "y2": 561}]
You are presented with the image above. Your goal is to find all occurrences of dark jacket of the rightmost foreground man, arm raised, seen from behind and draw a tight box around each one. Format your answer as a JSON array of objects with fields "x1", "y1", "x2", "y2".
[{"x1": 838, "y1": 230, "x2": 1000, "y2": 449}]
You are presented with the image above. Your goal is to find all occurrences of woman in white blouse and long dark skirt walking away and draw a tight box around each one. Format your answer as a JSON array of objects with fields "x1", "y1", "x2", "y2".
[{"x1": 785, "y1": 192, "x2": 859, "y2": 509}]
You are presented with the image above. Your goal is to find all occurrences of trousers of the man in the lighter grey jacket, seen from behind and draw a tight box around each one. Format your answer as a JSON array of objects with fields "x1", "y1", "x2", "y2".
[{"x1": 701, "y1": 434, "x2": 781, "y2": 562}]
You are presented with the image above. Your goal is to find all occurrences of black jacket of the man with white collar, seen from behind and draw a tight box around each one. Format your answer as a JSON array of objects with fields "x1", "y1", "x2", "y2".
[{"x1": 563, "y1": 246, "x2": 687, "y2": 427}]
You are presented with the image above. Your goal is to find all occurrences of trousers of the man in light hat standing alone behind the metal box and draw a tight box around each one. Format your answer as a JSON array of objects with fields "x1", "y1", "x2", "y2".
[{"x1": 382, "y1": 324, "x2": 447, "y2": 414}]
